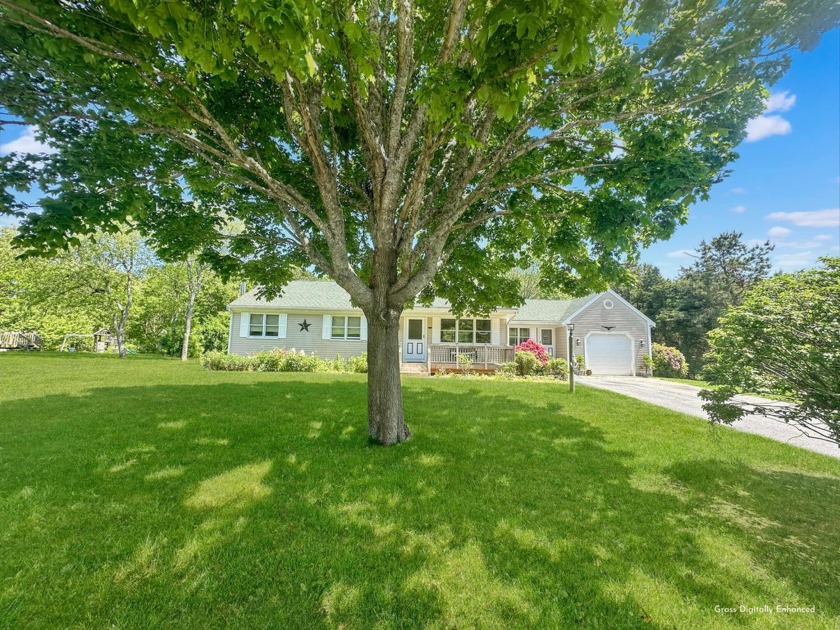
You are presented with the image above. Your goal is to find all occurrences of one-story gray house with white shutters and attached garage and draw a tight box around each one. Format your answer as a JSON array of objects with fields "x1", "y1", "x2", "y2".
[{"x1": 228, "y1": 280, "x2": 655, "y2": 375}]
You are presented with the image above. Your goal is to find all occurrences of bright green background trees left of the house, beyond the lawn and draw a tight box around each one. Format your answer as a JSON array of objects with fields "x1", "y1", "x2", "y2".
[{"x1": 0, "y1": 227, "x2": 238, "y2": 358}]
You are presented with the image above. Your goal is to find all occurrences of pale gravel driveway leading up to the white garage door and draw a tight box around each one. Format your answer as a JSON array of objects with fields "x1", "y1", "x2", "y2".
[{"x1": 576, "y1": 376, "x2": 840, "y2": 459}]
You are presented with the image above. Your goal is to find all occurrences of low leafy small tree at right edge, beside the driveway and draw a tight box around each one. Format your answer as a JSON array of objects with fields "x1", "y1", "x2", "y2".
[{"x1": 700, "y1": 258, "x2": 840, "y2": 445}]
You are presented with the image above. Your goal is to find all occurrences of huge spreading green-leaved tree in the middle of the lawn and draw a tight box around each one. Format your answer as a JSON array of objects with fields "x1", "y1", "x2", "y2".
[{"x1": 0, "y1": 0, "x2": 837, "y2": 444}]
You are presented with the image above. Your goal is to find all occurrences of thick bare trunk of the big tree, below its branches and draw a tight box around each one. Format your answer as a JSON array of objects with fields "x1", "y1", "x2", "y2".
[{"x1": 366, "y1": 309, "x2": 411, "y2": 446}]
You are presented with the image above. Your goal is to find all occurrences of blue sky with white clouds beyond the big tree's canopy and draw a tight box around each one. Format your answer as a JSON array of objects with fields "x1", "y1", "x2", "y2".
[{"x1": 0, "y1": 30, "x2": 840, "y2": 277}]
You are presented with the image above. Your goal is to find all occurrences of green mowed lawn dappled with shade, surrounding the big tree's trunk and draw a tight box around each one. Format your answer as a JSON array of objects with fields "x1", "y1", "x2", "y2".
[{"x1": 0, "y1": 353, "x2": 840, "y2": 629}]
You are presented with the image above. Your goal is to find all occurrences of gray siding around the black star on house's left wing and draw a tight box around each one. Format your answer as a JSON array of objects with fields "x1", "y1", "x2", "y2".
[{"x1": 230, "y1": 309, "x2": 367, "y2": 359}]
